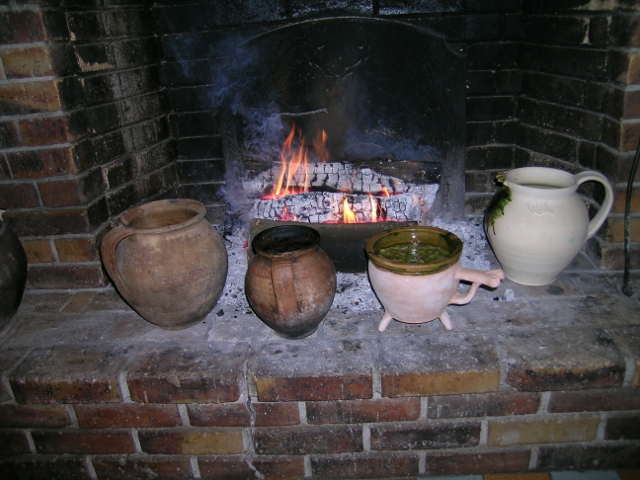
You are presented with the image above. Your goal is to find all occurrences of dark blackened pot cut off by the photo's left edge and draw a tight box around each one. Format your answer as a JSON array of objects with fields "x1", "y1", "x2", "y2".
[{"x1": 0, "y1": 217, "x2": 27, "y2": 332}]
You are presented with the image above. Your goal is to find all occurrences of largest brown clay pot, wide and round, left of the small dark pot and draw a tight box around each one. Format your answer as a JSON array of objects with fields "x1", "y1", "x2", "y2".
[{"x1": 101, "y1": 199, "x2": 227, "y2": 330}]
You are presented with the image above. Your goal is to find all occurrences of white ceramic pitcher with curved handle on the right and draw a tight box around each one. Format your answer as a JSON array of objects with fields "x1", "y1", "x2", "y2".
[{"x1": 485, "y1": 167, "x2": 613, "y2": 285}]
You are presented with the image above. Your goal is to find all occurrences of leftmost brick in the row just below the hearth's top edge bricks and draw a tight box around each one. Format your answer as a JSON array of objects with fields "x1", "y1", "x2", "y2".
[{"x1": 0, "y1": 404, "x2": 71, "y2": 428}]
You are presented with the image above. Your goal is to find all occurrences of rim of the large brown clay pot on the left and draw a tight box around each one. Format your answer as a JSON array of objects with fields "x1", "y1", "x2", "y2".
[{"x1": 120, "y1": 198, "x2": 207, "y2": 235}]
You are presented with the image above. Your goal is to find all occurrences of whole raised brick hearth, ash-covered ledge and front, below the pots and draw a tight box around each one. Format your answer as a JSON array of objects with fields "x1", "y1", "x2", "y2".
[{"x1": 0, "y1": 249, "x2": 640, "y2": 480}]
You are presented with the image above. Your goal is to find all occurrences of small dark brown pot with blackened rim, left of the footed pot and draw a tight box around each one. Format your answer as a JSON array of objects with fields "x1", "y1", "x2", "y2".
[{"x1": 245, "y1": 225, "x2": 336, "y2": 339}]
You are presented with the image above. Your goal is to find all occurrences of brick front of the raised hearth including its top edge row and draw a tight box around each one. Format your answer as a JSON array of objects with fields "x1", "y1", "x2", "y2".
[{"x1": 0, "y1": 329, "x2": 640, "y2": 480}]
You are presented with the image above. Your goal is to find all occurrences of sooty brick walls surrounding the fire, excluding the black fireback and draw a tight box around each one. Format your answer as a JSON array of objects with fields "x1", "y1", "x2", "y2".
[{"x1": 0, "y1": 0, "x2": 640, "y2": 288}]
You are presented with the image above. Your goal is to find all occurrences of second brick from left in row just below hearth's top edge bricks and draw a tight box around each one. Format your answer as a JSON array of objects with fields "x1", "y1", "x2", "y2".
[{"x1": 74, "y1": 403, "x2": 182, "y2": 428}]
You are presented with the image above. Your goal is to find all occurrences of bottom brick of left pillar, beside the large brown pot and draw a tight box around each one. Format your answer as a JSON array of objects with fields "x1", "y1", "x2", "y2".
[{"x1": 27, "y1": 262, "x2": 109, "y2": 288}]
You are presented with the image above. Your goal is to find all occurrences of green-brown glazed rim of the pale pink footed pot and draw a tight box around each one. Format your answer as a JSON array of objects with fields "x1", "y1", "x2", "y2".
[{"x1": 365, "y1": 225, "x2": 462, "y2": 275}]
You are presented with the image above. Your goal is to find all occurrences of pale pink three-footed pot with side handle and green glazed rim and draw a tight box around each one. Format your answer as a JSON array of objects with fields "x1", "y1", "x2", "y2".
[{"x1": 366, "y1": 226, "x2": 504, "y2": 332}]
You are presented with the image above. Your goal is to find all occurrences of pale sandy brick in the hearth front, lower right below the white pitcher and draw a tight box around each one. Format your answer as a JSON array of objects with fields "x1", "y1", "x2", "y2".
[{"x1": 487, "y1": 418, "x2": 600, "y2": 445}]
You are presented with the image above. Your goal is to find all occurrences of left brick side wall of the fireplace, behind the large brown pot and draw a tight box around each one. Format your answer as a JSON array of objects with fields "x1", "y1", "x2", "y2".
[{"x1": 0, "y1": 2, "x2": 176, "y2": 288}]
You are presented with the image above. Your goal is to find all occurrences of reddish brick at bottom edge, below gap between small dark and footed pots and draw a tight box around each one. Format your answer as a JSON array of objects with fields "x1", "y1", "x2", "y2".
[{"x1": 311, "y1": 454, "x2": 419, "y2": 480}]
